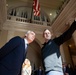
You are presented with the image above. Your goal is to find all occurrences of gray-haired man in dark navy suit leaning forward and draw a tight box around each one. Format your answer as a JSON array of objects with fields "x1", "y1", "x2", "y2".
[{"x1": 0, "y1": 31, "x2": 35, "y2": 75}]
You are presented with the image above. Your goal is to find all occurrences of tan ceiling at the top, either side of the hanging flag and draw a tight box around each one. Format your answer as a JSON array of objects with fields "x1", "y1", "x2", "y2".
[{"x1": 7, "y1": 0, "x2": 66, "y2": 21}]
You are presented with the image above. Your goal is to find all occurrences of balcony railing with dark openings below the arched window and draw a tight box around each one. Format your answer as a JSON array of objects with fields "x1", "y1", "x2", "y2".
[{"x1": 7, "y1": 15, "x2": 51, "y2": 26}]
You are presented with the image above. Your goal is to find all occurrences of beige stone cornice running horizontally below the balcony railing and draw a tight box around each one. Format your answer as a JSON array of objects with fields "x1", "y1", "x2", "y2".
[{"x1": 2, "y1": 20, "x2": 51, "y2": 34}]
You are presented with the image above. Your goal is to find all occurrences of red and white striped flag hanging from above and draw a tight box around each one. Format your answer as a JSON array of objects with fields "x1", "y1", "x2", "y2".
[{"x1": 33, "y1": 0, "x2": 40, "y2": 16}]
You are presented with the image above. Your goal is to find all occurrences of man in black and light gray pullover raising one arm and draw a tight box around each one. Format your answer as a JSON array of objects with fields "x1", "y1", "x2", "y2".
[{"x1": 41, "y1": 21, "x2": 76, "y2": 75}]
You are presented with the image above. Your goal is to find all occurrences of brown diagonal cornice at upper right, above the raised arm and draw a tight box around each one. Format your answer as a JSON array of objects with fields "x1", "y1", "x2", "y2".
[{"x1": 52, "y1": 0, "x2": 76, "y2": 33}]
